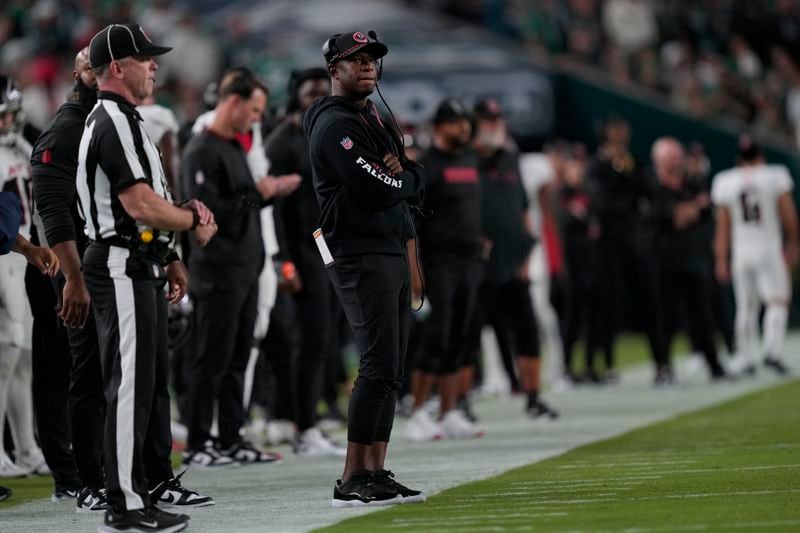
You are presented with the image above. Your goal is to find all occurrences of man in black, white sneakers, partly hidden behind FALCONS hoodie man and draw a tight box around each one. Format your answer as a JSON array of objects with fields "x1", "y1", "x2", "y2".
[{"x1": 266, "y1": 68, "x2": 345, "y2": 456}]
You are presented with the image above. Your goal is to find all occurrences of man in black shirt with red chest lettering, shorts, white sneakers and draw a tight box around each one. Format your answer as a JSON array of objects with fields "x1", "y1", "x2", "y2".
[{"x1": 406, "y1": 99, "x2": 483, "y2": 440}]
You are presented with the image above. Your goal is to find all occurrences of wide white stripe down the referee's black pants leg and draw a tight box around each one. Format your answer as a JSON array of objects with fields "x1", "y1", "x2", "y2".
[{"x1": 107, "y1": 246, "x2": 144, "y2": 511}]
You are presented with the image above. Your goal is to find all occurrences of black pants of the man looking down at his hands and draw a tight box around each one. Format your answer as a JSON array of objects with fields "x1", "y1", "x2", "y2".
[{"x1": 187, "y1": 277, "x2": 258, "y2": 451}]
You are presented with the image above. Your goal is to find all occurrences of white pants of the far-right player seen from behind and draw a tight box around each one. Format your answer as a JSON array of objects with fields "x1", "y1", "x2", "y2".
[{"x1": 732, "y1": 250, "x2": 791, "y2": 363}]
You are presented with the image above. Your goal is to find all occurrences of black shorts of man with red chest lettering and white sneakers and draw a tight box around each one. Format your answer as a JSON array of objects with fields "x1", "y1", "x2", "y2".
[{"x1": 417, "y1": 257, "x2": 483, "y2": 375}]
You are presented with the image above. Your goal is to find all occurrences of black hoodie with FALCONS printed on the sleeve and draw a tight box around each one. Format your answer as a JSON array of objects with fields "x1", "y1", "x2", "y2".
[{"x1": 303, "y1": 96, "x2": 425, "y2": 259}]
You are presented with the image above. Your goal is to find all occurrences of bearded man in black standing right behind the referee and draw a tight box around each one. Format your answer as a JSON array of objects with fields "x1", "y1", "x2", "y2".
[{"x1": 31, "y1": 47, "x2": 106, "y2": 510}]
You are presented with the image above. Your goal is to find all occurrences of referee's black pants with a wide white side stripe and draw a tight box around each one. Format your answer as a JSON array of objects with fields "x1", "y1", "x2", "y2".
[{"x1": 83, "y1": 243, "x2": 172, "y2": 512}]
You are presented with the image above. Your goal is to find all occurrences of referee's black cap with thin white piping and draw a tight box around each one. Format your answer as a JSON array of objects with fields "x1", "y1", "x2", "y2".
[{"x1": 89, "y1": 24, "x2": 172, "y2": 68}]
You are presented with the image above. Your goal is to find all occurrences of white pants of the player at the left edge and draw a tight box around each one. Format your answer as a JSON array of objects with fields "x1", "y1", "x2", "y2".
[{"x1": 0, "y1": 254, "x2": 37, "y2": 453}]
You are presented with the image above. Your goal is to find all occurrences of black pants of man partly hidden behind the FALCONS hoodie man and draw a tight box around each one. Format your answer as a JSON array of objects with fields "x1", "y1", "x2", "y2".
[{"x1": 293, "y1": 243, "x2": 334, "y2": 432}]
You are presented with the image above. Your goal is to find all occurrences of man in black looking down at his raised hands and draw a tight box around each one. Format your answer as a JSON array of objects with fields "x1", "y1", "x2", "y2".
[{"x1": 181, "y1": 68, "x2": 285, "y2": 466}]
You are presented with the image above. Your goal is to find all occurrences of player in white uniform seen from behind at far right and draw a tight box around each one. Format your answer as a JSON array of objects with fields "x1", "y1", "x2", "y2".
[{"x1": 711, "y1": 136, "x2": 800, "y2": 375}]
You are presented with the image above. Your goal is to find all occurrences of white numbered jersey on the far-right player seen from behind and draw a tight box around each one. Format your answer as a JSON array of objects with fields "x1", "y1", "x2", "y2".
[{"x1": 711, "y1": 165, "x2": 793, "y2": 262}]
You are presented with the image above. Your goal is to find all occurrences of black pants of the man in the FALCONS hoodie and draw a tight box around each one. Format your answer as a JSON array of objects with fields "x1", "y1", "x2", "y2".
[{"x1": 327, "y1": 254, "x2": 411, "y2": 445}]
